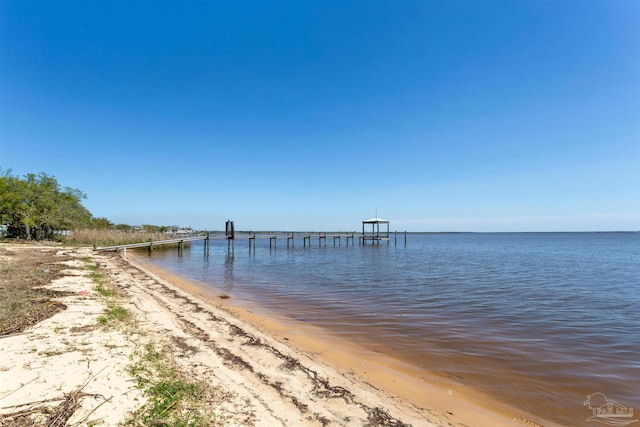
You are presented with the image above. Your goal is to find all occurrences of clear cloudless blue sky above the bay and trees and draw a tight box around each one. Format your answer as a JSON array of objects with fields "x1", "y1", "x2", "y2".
[{"x1": 0, "y1": 0, "x2": 640, "y2": 231}]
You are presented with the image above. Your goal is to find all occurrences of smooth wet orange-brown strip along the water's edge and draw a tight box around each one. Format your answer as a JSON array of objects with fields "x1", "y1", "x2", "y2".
[{"x1": 135, "y1": 257, "x2": 559, "y2": 426}]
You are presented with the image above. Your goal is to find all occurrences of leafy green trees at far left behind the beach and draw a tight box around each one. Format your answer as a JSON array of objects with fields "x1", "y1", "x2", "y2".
[{"x1": 0, "y1": 170, "x2": 106, "y2": 240}]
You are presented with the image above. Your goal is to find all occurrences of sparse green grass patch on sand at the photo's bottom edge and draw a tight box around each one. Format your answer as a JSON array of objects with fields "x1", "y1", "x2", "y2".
[{"x1": 128, "y1": 343, "x2": 216, "y2": 427}]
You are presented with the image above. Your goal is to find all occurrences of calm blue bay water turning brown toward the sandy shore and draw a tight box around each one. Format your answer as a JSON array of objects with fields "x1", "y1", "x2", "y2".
[{"x1": 142, "y1": 233, "x2": 640, "y2": 425}]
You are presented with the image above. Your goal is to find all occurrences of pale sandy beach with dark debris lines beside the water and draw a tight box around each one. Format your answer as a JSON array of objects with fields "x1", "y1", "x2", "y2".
[{"x1": 0, "y1": 244, "x2": 537, "y2": 426}]
